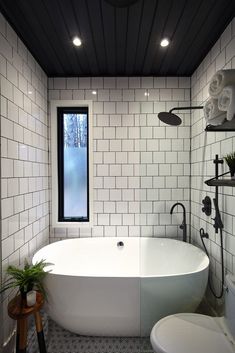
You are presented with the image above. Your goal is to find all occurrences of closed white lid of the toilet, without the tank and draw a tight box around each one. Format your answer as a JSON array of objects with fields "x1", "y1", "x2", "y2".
[{"x1": 150, "y1": 314, "x2": 235, "y2": 353}]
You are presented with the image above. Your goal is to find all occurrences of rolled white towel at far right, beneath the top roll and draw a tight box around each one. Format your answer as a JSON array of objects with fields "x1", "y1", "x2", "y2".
[{"x1": 218, "y1": 84, "x2": 235, "y2": 120}]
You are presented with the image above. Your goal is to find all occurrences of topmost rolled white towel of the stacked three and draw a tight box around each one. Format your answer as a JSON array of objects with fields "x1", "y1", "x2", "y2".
[{"x1": 209, "y1": 69, "x2": 235, "y2": 98}]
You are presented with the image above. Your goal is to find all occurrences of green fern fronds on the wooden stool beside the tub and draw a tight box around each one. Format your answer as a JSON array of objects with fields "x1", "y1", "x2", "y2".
[{"x1": 0, "y1": 260, "x2": 49, "y2": 299}]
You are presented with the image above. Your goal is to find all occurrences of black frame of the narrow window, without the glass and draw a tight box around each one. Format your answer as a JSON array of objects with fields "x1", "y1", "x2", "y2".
[{"x1": 57, "y1": 107, "x2": 90, "y2": 223}]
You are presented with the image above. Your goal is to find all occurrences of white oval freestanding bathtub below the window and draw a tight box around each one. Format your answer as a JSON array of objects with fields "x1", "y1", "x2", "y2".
[{"x1": 33, "y1": 237, "x2": 209, "y2": 336}]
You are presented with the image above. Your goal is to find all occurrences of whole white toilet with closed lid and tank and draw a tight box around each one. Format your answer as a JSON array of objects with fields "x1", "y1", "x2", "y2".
[{"x1": 150, "y1": 275, "x2": 235, "y2": 353}]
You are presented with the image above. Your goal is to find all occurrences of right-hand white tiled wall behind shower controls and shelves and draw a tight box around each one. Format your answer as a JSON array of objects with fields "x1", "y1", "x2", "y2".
[{"x1": 191, "y1": 19, "x2": 235, "y2": 304}]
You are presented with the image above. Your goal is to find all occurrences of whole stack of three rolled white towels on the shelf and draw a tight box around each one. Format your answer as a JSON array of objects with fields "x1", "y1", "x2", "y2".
[{"x1": 204, "y1": 70, "x2": 235, "y2": 125}]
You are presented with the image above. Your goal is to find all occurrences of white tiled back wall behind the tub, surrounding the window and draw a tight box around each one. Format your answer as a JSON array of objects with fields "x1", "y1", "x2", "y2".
[{"x1": 49, "y1": 77, "x2": 190, "y2": 241}]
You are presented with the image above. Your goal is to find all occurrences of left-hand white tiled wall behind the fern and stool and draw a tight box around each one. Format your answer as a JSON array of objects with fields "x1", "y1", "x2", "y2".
[{"x1": 0, "y1": 14, "x2": 49, "y2": 341}]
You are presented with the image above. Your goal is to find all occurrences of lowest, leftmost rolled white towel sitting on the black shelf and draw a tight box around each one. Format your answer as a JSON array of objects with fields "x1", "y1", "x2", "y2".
[{"x1": 203, "y1": 98, "x2": 225, "y2": 125}]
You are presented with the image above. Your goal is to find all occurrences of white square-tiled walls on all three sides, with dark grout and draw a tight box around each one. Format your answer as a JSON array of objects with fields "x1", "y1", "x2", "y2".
[{"x1": 0, "y1": 10, "x2": 235, "y2": 346}]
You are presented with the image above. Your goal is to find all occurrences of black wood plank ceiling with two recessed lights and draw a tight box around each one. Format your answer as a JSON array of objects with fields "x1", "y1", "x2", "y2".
[{"x1": 0, "y1": 0, "x2": 235, "y2": 76}]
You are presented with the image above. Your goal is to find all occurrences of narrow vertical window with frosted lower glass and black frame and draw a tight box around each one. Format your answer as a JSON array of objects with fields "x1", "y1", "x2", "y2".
[{"x1": 57, "y1": 107, "x2": 89, "y2": 222}]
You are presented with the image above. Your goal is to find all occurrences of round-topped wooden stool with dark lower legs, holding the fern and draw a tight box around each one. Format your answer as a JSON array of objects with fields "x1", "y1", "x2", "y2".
[{"x1": 8, "y1": 292, "x2": 46, "y2": 353}]
